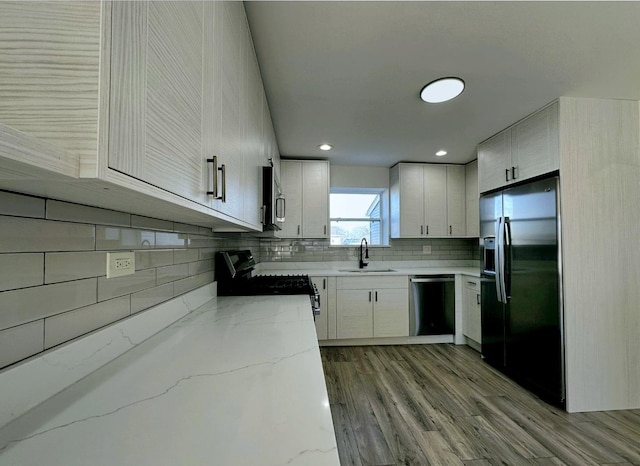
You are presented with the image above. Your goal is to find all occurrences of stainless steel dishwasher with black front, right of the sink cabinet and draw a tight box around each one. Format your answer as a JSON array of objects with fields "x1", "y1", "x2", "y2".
[{"x1": 409, "y1": 275, "x2": 455, "y2": 336}]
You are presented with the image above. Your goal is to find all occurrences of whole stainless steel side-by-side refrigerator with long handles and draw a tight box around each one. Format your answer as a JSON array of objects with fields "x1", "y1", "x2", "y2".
[{"x1": 480, "y1": 176, "x2": 565, "y2": 406}]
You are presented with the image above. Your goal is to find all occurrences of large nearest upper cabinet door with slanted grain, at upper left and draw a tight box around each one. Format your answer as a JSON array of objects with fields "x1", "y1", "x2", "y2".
[{"x1": 109, "y1": 1, "x2": 206, "y2": 203}]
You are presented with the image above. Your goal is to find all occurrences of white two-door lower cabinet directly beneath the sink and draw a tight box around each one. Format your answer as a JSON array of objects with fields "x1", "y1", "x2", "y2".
[{"x1": 336, "y1": 276, "x2": 409, "y2": 339}]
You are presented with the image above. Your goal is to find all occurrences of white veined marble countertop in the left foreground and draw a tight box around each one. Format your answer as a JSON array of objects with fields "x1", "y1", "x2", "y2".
[{"x1": 0, "y1": 296, "x2": 339, "y2": 466}]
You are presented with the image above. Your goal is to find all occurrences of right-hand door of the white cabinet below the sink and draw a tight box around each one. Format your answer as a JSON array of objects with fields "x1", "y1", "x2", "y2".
[{"x1": 373, "y1": 288, "x2": 409, "y2": 337}]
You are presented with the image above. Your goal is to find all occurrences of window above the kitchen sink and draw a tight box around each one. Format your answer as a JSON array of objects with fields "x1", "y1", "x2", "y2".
[{"x1": 329, "y1": 190, "x2": 389, "y2": 246}]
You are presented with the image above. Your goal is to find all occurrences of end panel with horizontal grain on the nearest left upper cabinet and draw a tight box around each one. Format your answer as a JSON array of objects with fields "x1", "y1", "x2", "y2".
[{"x1": 0, "y1": 2, "x2": 102, "y2": 180}]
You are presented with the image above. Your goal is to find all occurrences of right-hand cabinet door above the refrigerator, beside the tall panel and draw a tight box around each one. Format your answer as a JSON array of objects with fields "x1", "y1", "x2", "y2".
[{"x1": 511, "y1": 102, "x2": 560, "y2": 181}]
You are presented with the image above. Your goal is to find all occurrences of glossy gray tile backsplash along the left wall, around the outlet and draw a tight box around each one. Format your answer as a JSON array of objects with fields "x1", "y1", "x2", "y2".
[{"x1": 0, "y1": 191, "x2": 255, "y2": 368}]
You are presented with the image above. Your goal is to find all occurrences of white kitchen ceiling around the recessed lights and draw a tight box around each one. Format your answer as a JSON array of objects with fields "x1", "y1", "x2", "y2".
[{"x1": 245, "y1": 1, "x2": 640, "y2": 167}]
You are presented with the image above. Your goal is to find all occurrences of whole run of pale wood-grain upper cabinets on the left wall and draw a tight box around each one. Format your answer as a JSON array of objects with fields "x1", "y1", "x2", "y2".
[{"x1": 0, "y1": 1, "x2": 279, "y2": 230}]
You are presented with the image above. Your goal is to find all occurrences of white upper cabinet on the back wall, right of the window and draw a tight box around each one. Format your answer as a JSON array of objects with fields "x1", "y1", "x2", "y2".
[{"x1": 390, "y1": 163, "x2": 466, "y2": 238}]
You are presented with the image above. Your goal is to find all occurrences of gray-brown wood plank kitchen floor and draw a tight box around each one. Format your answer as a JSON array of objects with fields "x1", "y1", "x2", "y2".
[{"x1": 321, "y1": 344, "x2": 640, "y2": 466}]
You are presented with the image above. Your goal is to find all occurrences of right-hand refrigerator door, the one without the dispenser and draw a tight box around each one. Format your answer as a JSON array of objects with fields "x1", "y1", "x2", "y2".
[{"x1": 503, "y1": 178, "x2": 563, "y2": 401}]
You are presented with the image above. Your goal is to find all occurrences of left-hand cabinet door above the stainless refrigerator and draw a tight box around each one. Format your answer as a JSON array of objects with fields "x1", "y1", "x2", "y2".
[{"x1": 478, "y1": 129, "x2": 511, "y2": 193}]
